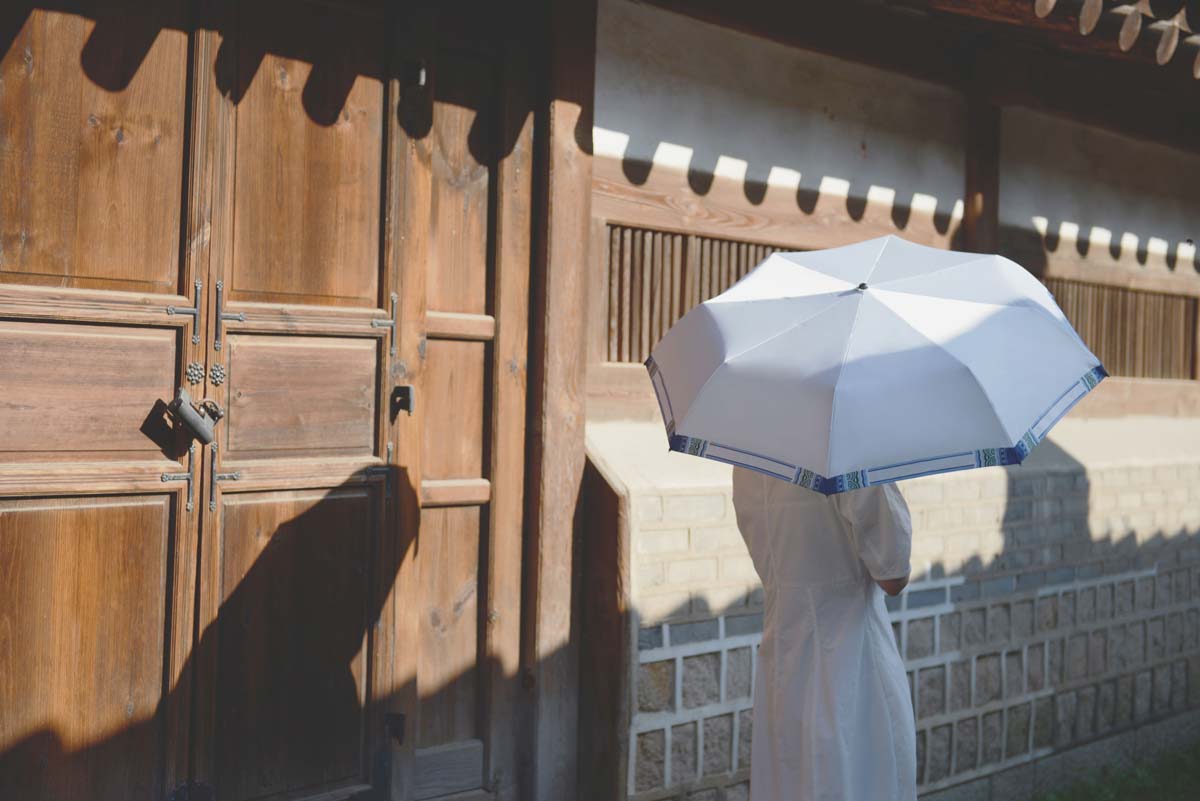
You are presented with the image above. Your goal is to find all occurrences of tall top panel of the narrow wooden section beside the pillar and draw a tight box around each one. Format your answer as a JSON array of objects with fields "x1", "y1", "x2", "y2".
[{"x1": 428, "y1": 48, "x2": 498, "y2": 314}]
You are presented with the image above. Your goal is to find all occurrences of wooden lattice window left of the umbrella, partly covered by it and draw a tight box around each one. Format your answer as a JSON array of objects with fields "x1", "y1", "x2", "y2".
[{"x1": 607, "y1": 225, "x2": 784, "y2": 362}]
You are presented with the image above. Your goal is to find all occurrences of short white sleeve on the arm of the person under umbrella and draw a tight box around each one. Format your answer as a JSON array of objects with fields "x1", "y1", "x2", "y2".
[{"x1": 838, "y1": 484, "x2": 912, "y2": 580}]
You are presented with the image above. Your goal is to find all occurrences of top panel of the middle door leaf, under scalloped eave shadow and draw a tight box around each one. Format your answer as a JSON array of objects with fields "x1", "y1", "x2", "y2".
[{"x1": 230, "y1": 2, "x2": 386, "y2": 307}]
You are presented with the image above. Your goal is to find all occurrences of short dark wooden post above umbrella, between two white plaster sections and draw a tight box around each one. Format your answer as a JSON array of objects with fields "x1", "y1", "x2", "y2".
[{"x1": 962, "y1": 88, "x2": 1000, "y2": 253}]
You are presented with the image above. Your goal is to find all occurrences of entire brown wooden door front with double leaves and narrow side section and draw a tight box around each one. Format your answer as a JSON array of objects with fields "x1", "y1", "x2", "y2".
[{"x1": 0, "y1": 0, "x2": 533, "y2": 801}]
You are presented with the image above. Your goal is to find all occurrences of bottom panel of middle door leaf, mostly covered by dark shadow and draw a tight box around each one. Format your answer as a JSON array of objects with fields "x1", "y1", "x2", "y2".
[{"x1": 206, "y1": 486, "x2": 380, "y2": 801}]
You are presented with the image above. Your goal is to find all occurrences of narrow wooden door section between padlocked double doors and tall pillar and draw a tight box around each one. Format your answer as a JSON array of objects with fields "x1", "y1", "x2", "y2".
[{"x1": 396, "y1": 4, "x2": 533, "y2": 800}]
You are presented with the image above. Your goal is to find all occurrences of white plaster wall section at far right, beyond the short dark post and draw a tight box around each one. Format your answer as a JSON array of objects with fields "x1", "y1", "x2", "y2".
[{"x1": 1000, "y1": 108, "x2": 1200, "y2": 261}]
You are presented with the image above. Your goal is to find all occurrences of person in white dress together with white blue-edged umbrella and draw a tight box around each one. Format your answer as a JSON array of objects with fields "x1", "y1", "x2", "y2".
[{"x1": 647, "y1": 236, "x2": 1106, "y2": 801}]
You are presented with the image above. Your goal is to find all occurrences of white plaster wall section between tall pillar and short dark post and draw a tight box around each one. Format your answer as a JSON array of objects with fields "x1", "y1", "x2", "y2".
[{"x1": 595, "y1": 0, "x2": 965, "y2": 213}]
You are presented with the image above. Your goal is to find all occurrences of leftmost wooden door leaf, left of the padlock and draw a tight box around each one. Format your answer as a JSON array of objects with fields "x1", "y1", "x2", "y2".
[{"x1": 0, "y1": 1, "x2": 203, "y2": 801}]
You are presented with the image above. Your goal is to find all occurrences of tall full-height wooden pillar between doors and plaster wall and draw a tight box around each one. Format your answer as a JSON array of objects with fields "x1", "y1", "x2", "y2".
[{"x1": 521, "y1": 0, "x2": 596, "y2": 801}]
